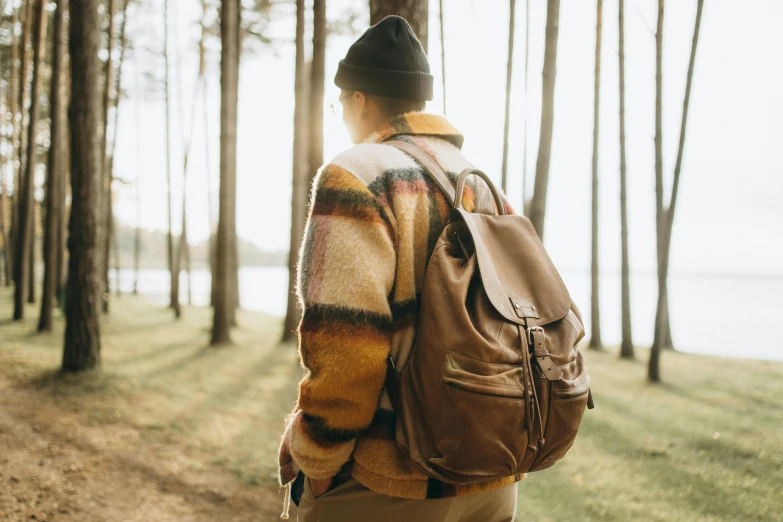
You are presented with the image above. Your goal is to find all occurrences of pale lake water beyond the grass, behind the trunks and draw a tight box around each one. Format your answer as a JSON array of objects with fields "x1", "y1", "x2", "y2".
[{"x1": 112, "y1": 267, "x2": 783, "y2": 360}]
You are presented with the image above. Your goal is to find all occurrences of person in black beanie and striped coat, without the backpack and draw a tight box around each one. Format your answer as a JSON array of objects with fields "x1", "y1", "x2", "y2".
[{"x1": 279, "y1": 16, "x2": 520, "y2": 522}]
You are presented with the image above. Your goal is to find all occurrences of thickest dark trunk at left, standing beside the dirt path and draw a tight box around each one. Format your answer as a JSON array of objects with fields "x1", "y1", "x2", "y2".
[{"x1": 62, "y1": 0, "x2": 103, "y2": 372}]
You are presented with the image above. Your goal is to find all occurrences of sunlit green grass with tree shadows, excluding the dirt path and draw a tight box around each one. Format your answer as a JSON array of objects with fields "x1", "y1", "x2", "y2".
[{"x1": 0, "y1": 290, "x2": 783, "y2": 521}]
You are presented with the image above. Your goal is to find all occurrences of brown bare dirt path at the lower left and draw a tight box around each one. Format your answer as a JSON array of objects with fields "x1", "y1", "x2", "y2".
[{"x1": 0, "y1": 378, "x2": 295, "y2": 522}]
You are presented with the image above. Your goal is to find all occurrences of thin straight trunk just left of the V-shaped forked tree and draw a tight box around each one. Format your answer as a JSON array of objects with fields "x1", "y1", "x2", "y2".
[{"x1": 618, "y1": 0, "x2": 635, "y2": 359}]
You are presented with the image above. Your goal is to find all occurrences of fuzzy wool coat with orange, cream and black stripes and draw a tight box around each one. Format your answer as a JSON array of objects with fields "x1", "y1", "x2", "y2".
[{"x1": 279, "y1": 113, "x2": 519, "y2": 499}]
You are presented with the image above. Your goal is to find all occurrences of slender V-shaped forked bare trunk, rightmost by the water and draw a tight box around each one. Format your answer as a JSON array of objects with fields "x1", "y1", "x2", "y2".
[{"x1": 647, "y1": 0, "x2": 704, "y2": 382}]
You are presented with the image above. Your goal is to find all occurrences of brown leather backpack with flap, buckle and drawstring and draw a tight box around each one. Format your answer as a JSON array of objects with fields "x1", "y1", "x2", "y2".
[{"x1": 387, "y1": 140, "x2": 593, "y2": 484}]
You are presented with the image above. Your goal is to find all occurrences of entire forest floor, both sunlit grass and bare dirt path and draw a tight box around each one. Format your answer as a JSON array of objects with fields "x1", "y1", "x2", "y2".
[{"x1": 0, "y1": 289, "x2": 783, "y2": 522}]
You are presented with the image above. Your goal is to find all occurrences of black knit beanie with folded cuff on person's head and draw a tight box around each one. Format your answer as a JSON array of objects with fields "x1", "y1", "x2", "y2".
[{"x1": 334, "y1": 15, "x2": 433, "y2": 101}]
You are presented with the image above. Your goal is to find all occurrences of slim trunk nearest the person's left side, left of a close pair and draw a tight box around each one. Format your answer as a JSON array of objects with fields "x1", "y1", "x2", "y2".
[{"x1": 282, "y1": 0, "x2": 309, "y2": 342}]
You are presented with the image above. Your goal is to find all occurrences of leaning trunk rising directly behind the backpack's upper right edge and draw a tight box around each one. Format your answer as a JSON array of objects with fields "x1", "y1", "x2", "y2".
[{"x1": 530, "y1": 0, "x2": 560, "y2": 240}]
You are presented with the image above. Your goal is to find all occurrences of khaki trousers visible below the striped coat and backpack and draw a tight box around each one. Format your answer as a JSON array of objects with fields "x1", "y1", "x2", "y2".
[{"x1": 298, "y1": 479, "x2": 517, "y2": 522}]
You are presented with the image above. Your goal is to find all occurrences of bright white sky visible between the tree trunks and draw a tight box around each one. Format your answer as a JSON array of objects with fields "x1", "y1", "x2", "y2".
[{"x1": 116, "y1": 0, "x2": 783, "y2": 274}]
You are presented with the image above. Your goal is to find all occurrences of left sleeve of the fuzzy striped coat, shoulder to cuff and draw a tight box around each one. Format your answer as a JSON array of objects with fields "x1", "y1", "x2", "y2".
[{"x1": 281, "y1": 165, "x2": 396, "y2": 482}]
